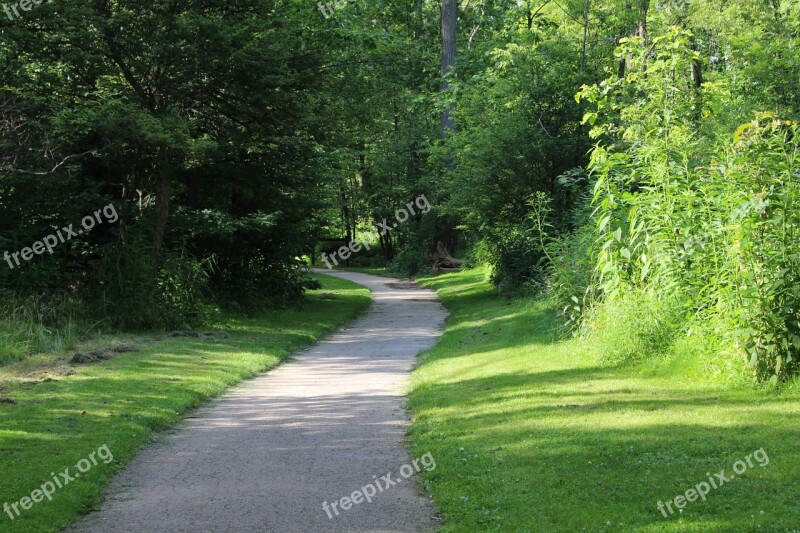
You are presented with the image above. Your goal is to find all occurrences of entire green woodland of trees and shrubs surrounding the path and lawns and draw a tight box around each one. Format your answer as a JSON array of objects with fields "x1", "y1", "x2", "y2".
[{"x1": 0, "y1": 0, "x2": 800, "y2": 531}]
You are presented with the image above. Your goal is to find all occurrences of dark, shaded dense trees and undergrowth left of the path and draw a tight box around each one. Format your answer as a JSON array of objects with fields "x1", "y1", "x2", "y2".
[{"x1": 0, "y1": 0, "x2": 334, "y2": 334}]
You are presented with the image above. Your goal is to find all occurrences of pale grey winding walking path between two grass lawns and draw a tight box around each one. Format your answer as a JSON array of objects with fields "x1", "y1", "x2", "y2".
[{"x1": 70, "y1": 272, "x2": 447, "y2": 533}]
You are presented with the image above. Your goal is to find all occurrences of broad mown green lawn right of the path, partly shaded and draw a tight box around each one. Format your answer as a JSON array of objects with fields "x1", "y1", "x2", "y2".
[{"x1": 410, "y1": 270, "x2": 800, "y2": 532}]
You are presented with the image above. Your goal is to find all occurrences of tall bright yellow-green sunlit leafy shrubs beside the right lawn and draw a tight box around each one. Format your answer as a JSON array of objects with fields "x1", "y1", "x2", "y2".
[{"x1": 568, "y1": 27, "x2": 800, "y2": 381}]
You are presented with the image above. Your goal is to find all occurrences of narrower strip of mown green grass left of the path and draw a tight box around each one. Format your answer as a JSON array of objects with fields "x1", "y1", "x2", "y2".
[{"x1": 0, "y1": 276, "x2": 370, "y2": 532}]
